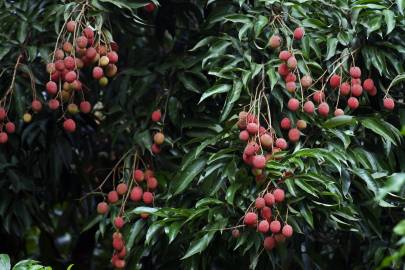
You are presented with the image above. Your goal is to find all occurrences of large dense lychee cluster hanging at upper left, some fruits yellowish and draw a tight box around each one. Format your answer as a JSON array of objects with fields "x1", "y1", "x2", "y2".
[{"x1": 45, "y1": 14, "x2": 118, "y2": 133}]
